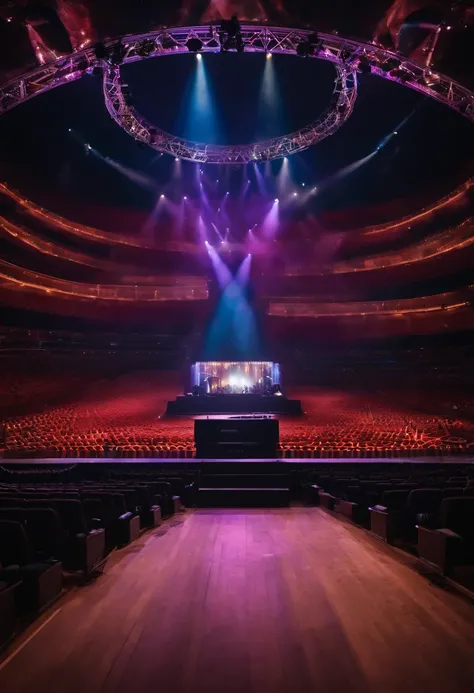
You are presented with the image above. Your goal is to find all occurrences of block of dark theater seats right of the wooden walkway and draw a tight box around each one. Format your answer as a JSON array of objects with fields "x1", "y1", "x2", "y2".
[{"x1": 307, "y1": 465, "x2": 474, "y2": 587}]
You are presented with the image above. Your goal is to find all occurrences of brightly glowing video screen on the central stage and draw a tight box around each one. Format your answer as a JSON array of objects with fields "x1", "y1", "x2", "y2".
[{"x1": 191, "y1": 361, "x2": 281, "y2": 395}]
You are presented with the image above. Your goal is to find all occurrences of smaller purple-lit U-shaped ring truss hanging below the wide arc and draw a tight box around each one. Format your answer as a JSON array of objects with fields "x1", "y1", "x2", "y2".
[{"x1": 104, "y1": 57, "x2": 357, "y2": 164}]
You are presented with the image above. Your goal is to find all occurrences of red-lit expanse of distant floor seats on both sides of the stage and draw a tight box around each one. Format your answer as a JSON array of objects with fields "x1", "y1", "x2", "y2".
[{"x1": 4, "y1": 372, "x2": 474, "y2": 458}]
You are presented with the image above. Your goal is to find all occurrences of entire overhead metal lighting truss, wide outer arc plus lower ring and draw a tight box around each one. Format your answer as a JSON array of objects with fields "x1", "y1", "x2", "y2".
[{"x1": 0, "y1": 24, "x2": 474, "y2": 163}]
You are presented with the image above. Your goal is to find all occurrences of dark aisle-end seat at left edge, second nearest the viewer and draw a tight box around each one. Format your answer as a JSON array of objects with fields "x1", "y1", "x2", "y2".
[{"x1": 0, "y1": 520, "x2": 63, "y2": 612}]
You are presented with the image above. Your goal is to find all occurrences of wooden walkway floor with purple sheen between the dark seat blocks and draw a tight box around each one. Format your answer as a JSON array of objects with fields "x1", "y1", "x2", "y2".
[{"x1": 0, "y1": 508, "x2": 474, "y2": 693}]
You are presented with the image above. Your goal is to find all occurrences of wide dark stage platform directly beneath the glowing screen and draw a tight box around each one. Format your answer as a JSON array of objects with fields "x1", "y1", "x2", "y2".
[{"x1": 166, "y1": 394, "x2": 303, "y2": 416}]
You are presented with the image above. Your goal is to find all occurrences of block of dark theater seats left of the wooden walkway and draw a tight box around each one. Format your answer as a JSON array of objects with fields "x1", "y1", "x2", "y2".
[{"x1": 0, "y1": 473, "x2": 194, "y2": 646}]
